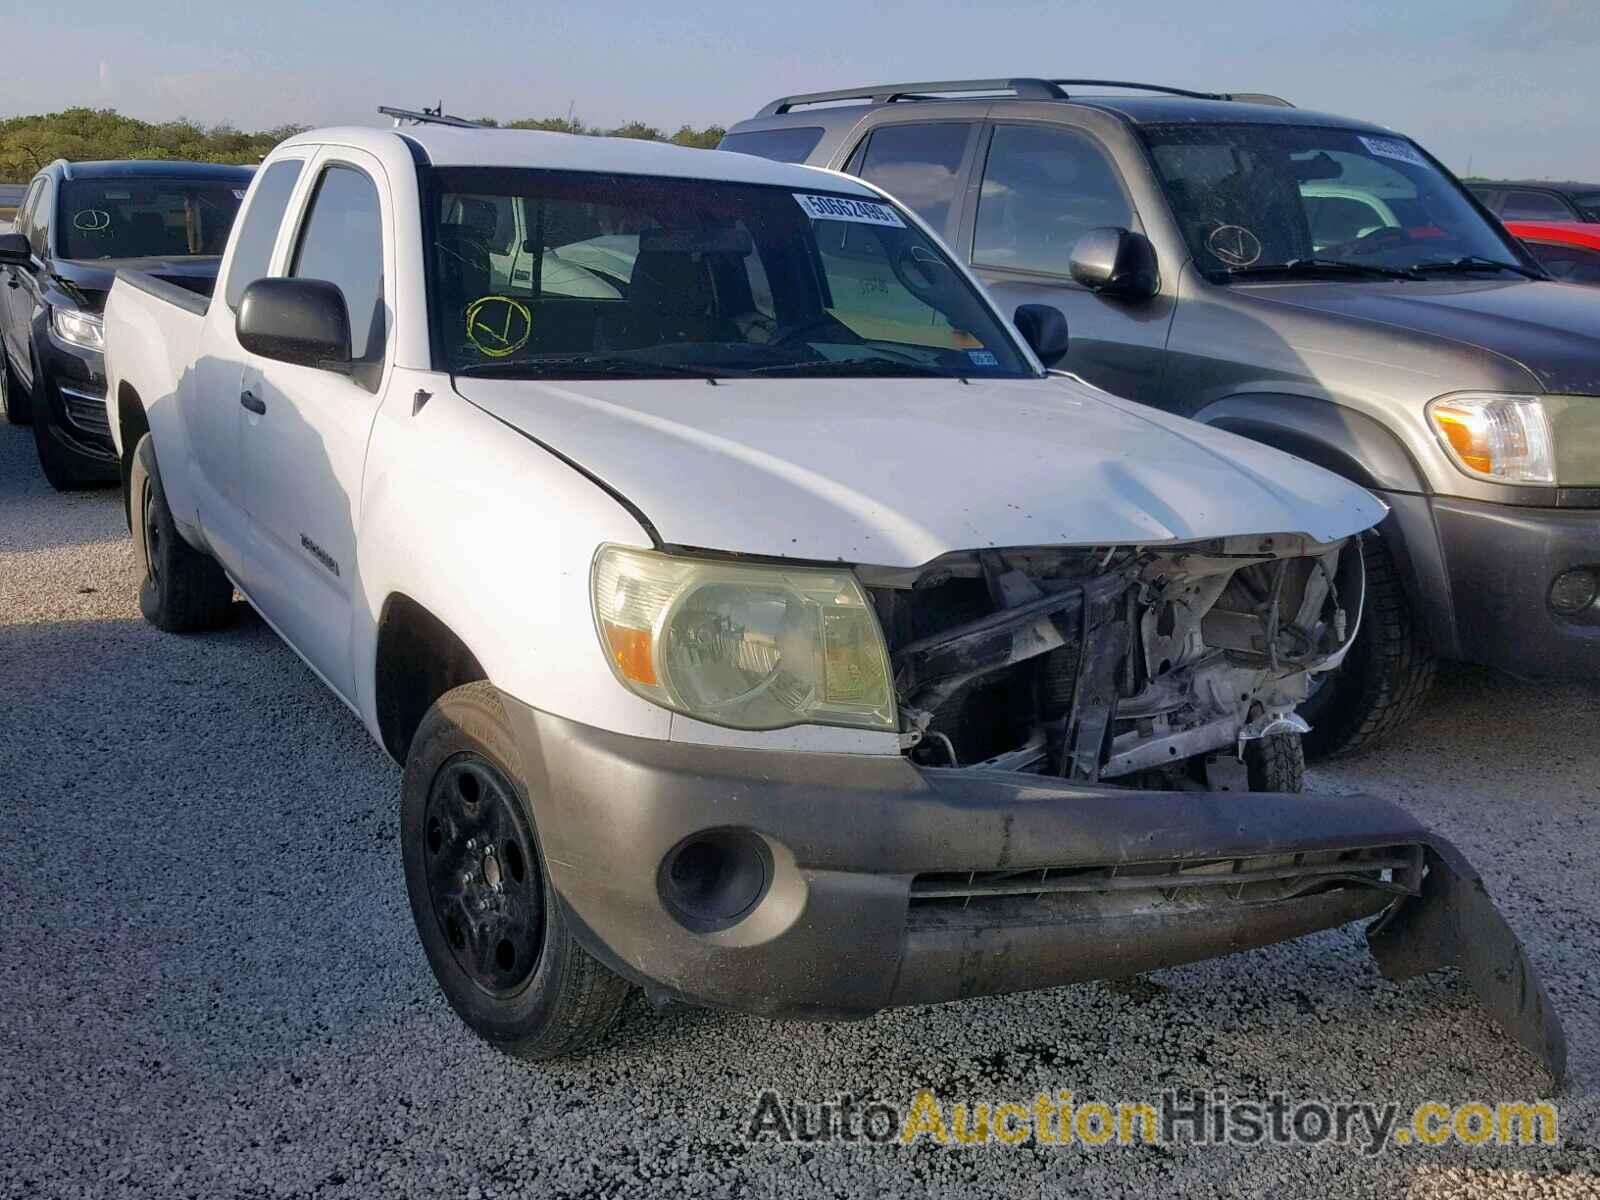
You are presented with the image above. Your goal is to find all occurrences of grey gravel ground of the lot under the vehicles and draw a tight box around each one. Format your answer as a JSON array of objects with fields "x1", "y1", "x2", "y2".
[{"x1": 0, "y1": 426, "x2": 1600, "y2": 1198}]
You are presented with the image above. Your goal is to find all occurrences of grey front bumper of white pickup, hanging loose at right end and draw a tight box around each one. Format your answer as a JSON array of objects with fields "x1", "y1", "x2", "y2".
[{"x1": 506, "y1": 698, "x2": 1566, "y2": 1083}]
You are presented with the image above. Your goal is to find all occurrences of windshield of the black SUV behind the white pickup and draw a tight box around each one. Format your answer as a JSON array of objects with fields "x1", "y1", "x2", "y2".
[{"x1": 56, "y1": 178, "x2": 250, "y2": 259}]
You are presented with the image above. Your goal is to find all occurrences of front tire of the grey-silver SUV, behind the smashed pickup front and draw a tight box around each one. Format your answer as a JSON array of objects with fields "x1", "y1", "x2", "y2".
[{"x1": 1299, "y1": 533, "x2": 1437, "y2": 762}]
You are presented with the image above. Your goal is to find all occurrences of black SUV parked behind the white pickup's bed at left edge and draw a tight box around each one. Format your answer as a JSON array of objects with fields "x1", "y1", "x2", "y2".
[{"x1": 0, "y1": 160, "x2": 254, "y2": 490}]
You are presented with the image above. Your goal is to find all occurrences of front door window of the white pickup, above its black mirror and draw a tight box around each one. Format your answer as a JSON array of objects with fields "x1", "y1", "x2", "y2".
[{"x1": 290, "y1": 166, "x2": 386, "y2": 363}]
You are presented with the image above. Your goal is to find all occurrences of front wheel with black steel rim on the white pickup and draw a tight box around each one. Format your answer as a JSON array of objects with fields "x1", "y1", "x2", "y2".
[{"x1": 400, "y1": 683, "x2": 630, "y2": 1059}]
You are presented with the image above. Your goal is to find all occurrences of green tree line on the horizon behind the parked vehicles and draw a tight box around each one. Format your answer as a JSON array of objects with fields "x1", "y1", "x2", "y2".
[{"x1": 0, "y1": 109, "x2": 723, "y2": 182}]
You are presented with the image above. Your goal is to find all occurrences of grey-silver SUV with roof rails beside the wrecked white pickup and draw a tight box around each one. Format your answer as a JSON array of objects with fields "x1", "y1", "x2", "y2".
[{"x1": 722, "y1": 78, "x2": 1600, "y2": 754}]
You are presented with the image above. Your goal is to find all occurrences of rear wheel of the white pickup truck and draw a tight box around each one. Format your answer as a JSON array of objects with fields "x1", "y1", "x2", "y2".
[{"x1": 128, "y1": 434, "x2": 234, "y2": 634}]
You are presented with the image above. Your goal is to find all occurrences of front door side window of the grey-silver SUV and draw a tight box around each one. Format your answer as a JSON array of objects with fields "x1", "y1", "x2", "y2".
[{"x1": 973, "y1": 125, "x2": 1133, "y2": 275}]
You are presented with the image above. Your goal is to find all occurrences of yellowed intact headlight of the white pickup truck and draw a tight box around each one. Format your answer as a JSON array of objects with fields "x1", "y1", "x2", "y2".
[{"x1": 592, "y1": 546, "x2": 898, "y2": 731}]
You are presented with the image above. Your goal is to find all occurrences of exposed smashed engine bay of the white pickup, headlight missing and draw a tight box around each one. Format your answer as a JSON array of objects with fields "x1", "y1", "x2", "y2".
[{"x1": 859, "y1": 534, "x2": 1365, "y2": 787}]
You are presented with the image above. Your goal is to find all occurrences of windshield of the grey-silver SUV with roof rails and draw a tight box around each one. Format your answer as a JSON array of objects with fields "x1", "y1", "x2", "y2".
[{"x1": 1141, "y1": 125, "x2": 1523, "y2": 278}]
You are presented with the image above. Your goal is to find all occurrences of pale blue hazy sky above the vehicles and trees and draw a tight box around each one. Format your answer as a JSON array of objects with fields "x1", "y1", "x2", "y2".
[{"x1": 0, "y1": 0, "x2": 1600, "y2": 179}]
